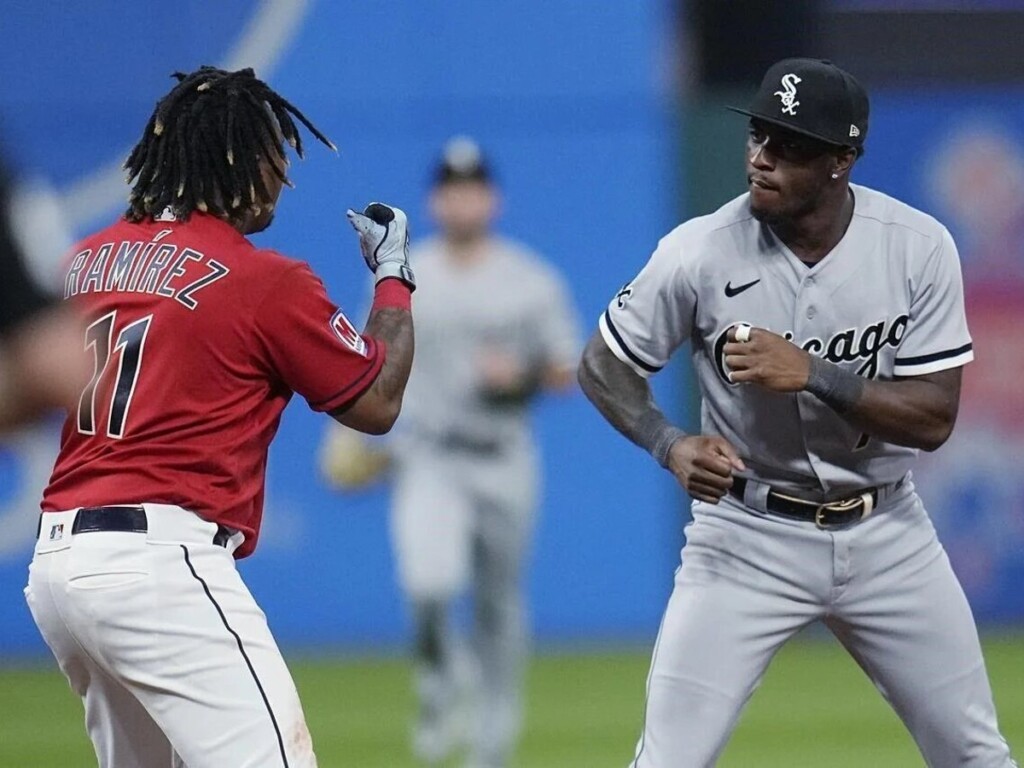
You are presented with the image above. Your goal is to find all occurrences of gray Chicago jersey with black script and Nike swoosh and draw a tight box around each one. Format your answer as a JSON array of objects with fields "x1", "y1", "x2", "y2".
[{"x1": 600, "y1": 184, "x2": 973, "y2": 496}]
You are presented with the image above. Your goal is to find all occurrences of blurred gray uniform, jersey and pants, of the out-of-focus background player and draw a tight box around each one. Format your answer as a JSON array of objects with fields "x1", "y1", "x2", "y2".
[{"x1": 392, "y1": 238, "x2": 579, "y2": 765}]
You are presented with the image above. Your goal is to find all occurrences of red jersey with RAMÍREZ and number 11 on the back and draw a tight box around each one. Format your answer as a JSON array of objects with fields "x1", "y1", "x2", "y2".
[{"x1": 42, "y1": 213, "x2": 384, "y2": 557}]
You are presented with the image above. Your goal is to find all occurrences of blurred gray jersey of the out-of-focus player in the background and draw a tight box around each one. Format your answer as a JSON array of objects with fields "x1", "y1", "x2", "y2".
[{"x1": 399, "y1": 238, "x2": 580, "y2": 450}]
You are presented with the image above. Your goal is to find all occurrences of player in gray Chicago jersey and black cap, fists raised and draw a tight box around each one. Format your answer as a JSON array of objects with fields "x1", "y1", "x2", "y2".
[{"x1": 580, "y1": 58, "x2": 1014, "y2": 768}]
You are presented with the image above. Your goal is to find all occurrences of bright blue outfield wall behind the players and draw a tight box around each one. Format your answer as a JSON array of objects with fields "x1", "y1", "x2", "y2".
[{"x1": 0, "y1": 0, "x2": 684, "y2": 654}]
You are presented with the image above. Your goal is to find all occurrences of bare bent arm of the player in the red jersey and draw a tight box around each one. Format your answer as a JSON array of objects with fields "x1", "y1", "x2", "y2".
[{"x1": 331, "y1": 288, "x2": 414, "y2": 434}]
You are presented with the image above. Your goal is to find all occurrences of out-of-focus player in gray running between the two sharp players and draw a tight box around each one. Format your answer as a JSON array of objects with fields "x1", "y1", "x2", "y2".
[{"x1": 323, "y1": 137, "x2": 579, "y2": 768}]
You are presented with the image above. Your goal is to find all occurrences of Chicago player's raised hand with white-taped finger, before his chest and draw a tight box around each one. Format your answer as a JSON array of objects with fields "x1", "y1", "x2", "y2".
[{"x1": 724, "y1": 328, "x2": 811, "y2": 392}]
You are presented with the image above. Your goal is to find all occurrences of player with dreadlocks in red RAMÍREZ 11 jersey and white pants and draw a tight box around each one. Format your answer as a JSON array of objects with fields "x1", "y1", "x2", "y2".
[{"x1": 26, "y1": 67, "x2": 415, "y2": 768}]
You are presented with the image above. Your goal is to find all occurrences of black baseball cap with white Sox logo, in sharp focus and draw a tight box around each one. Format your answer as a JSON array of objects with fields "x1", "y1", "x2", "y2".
[{"x1": 728, "y1": 58, "x2": 868, "y2": 155}]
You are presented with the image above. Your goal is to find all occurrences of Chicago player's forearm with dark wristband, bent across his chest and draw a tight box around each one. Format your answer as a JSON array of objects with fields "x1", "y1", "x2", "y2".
[{"x1": 808, "y1": 362, "x2": 959, "y2": 451}]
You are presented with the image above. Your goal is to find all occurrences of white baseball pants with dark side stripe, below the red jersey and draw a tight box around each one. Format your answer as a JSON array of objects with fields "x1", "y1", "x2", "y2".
[{"x1": 25, "y1": 504, "x2": 316, "y2": 768}]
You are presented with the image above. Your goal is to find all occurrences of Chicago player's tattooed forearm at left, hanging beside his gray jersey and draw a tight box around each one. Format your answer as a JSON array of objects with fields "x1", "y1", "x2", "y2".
[{"x1": 578, "y1": 333, "x2": 685, "y2": 466}]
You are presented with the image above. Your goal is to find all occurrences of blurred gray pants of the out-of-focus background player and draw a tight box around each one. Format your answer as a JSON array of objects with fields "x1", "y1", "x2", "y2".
[{"x1": 391, "y1": 442, "x2": 537, "y2": 766}]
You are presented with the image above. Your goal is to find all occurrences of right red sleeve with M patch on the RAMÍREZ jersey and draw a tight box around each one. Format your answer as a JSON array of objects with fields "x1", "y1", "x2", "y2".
[{"x1": 256, "y1": 262, "x2": 385, "y2": 412}]
